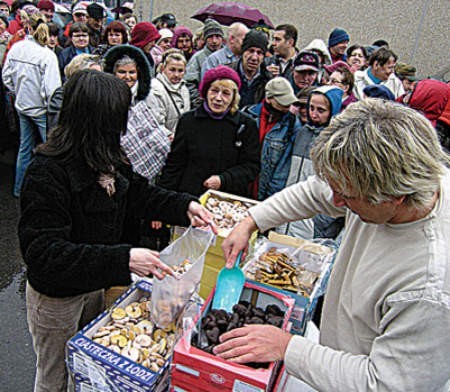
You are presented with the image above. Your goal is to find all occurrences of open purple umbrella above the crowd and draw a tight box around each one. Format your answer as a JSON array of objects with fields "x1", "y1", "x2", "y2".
[{"x1": 191, "y1": 1, "x2": 274, "y2": 29}]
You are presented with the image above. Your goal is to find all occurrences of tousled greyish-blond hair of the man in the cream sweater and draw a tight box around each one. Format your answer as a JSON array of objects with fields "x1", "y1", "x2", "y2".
[{"x1": 311, "y1": 99, "x2": 450, "y2": 209}]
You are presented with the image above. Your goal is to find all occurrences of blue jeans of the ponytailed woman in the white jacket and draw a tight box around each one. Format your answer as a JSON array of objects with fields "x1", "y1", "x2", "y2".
[{"x1": 14, "y1": 113, "x2": 47, "y2": 197}]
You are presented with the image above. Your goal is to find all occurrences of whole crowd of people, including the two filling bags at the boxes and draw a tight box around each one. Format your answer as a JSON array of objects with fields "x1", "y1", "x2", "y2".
[{"x1": 0, "y1": 0, "x2": 450, "y2": 391}]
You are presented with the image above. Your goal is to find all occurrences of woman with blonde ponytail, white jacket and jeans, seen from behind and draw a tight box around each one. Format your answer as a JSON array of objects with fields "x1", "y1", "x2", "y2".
[{"x1": 2, "y1": 13, "x2": 61, "y2": 197}]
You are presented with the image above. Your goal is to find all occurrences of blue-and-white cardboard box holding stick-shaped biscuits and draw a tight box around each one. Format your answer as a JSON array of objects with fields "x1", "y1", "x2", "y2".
[{"x1": 242, "y1": 232, "x2": 336, "y2": 335}]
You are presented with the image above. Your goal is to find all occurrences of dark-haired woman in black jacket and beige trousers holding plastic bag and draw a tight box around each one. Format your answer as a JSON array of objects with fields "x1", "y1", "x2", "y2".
[{"x1": 19, "y1": 70, "x2": 210, "y2": 391}]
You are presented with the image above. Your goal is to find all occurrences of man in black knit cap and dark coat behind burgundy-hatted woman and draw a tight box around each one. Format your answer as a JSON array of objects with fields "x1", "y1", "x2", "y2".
[{"x1": 227, "y1": 30, "x2": 272, "y2": 108}]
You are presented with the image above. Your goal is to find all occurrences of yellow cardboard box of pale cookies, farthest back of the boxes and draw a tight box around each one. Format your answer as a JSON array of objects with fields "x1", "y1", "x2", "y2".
[{"x1": 176, "y1": 190, "x2": 259, "y2": 299}]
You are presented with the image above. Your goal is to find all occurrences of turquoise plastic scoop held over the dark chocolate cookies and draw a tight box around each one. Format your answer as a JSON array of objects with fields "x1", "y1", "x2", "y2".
[{"x1": 212, "y1": 252, "x2": 245, "y2": 312}]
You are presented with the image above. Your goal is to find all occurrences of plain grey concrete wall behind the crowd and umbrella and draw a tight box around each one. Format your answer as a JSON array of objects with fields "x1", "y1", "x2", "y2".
[{"x1": 135, "y1": 0, "x2": 450, "y2": 80}]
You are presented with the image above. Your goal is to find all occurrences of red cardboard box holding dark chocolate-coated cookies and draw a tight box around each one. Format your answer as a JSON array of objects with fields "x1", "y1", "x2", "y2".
[{"x1": 171, "y1": 281, "x2": 294, "y2": 392}]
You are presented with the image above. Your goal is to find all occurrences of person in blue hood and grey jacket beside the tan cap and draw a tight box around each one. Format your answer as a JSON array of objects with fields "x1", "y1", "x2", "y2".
[{"x1": 277, "y1": 86, "x2": 343, "y2": 239}]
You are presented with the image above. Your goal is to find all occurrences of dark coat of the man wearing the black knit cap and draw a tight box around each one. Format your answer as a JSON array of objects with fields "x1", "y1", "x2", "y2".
[{"x1": 229, "y1": 58, "x2": 273, "y2": 108}]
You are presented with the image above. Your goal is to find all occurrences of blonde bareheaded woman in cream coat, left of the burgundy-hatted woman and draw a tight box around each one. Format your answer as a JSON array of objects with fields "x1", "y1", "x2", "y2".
[{"x1": 151, "y1": 49, "x2": 191, "y2": 138}]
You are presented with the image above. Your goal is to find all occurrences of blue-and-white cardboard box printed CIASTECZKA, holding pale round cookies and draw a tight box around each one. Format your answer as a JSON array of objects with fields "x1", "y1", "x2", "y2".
[{"x1": 66, "y1": 281, "x2": 169, "y2": 392}]
